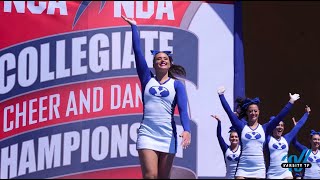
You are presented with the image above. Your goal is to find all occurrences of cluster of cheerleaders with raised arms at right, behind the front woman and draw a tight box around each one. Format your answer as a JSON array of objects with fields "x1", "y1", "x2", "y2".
[{"x1": 212, "y1": 87, "x2": 320, "y2": 179}]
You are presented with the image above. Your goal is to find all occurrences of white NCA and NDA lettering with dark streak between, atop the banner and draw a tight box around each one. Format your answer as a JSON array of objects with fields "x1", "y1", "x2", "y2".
[{"x1": 4, "y1": 1, "x2": 175, "y2": 28}]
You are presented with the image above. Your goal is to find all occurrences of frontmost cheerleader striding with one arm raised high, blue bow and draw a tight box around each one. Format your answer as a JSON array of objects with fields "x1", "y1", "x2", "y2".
[{"x1": 122, "y1": 16, "x2": 191, "y2": 179}]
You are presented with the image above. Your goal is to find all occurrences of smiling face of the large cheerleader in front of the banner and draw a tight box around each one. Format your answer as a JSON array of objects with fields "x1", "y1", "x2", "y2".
[{"x1": 153, "y1": 52, "x2": 171, "y2": 73}]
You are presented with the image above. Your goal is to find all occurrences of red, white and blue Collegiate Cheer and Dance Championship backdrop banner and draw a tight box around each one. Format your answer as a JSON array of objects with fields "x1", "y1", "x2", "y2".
[{"x1": 0, "y1": 1, "x2": 244, "y2": 179}]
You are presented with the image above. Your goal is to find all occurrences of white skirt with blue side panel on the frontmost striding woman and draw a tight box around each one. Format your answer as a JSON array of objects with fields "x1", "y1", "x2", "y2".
[{"x1": 137, "y1": 119, "x2": 177, "y2": 154}]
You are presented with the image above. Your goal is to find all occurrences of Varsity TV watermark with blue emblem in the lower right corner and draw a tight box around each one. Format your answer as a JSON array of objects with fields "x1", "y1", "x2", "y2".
[{"x1": 281, "y1": 149, "x2": 311, "y2": 172}]
